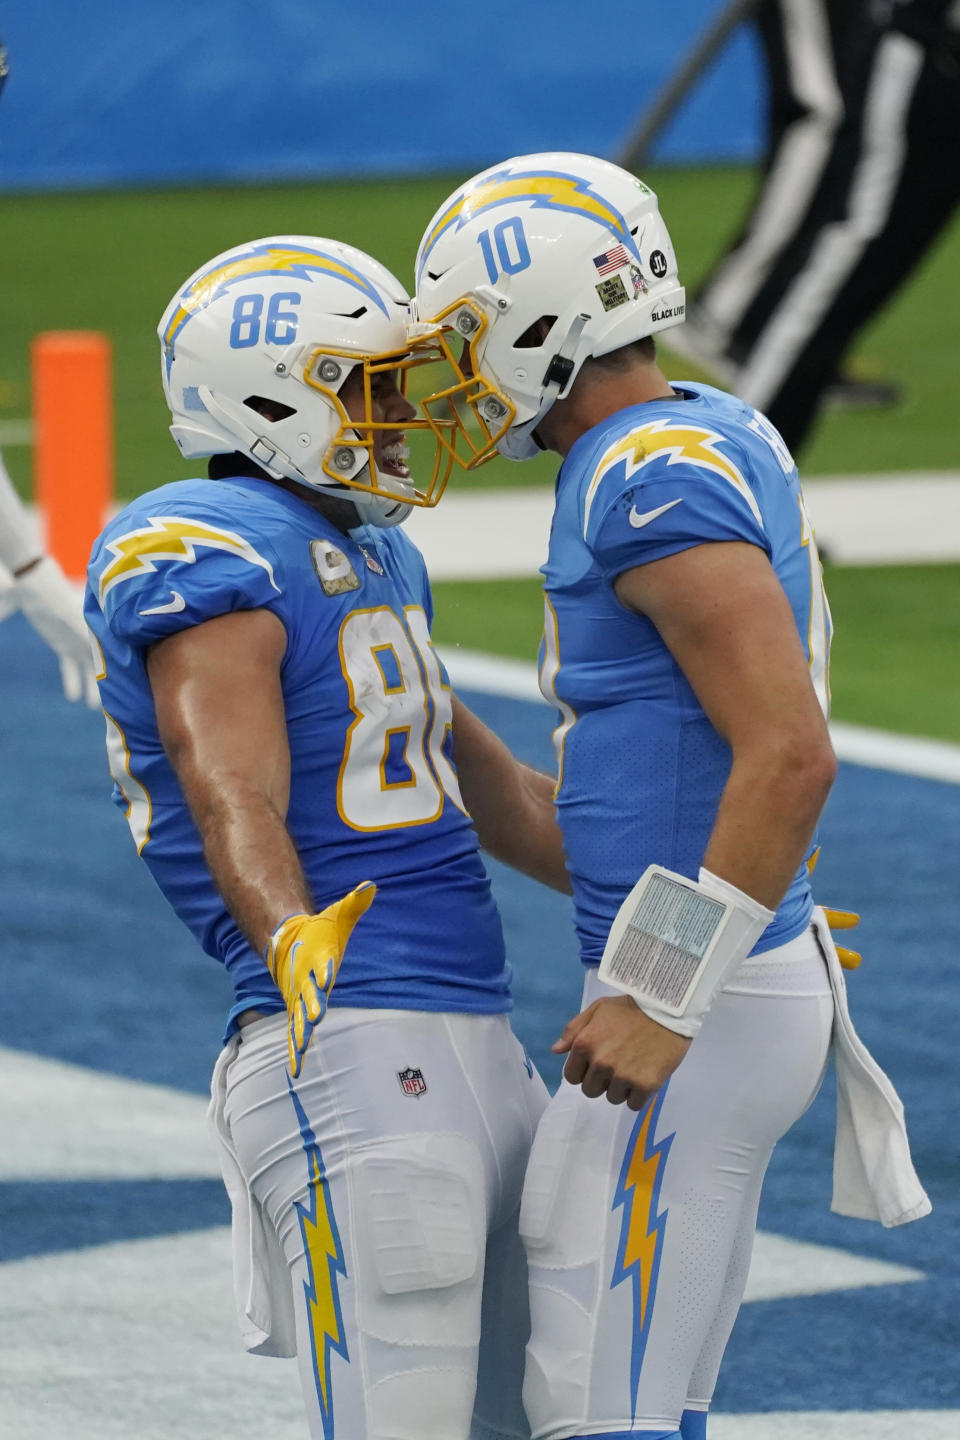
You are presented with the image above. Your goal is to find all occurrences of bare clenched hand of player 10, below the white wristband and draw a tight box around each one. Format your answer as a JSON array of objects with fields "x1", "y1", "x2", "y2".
[{"x1": 553, "y1": 995, "x2": 691, "y2": 1110}]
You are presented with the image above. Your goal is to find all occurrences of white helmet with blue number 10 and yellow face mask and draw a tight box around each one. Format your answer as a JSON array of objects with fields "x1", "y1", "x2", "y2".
[{"x1": 410, "y1": 153, "x2": 684, "y2": 469}]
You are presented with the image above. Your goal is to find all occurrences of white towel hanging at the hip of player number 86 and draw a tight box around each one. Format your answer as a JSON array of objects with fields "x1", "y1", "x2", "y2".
[{"x1": 207, "y1": 1015, "x2": 296, "y2": 1358}]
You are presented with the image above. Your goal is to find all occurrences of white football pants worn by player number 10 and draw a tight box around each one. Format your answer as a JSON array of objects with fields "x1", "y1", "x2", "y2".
[{"x1": 521, "y1": 932, "x2": 833, "y2": 1440}]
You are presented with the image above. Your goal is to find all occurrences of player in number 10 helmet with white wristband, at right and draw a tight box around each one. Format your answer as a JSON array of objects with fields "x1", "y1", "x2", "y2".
[{"x1": 412, "y1": 154, "x2": 925, "y2": 1440}]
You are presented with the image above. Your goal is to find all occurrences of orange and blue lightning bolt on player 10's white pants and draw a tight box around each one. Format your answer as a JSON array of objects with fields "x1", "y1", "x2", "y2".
[{"x1": 610, "y1": 1086, "x2": 674, "y2": 1417}]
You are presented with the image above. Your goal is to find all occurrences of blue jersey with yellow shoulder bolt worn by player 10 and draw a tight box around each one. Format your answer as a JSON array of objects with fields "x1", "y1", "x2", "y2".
[{"x1": 540, "y1": 382, "x2": 832, "y2": 965}]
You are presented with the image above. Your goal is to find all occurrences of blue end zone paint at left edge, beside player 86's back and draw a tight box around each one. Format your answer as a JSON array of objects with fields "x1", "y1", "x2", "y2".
[{"x1": 0, "y1": 615, "x2": 238, "y2": 1093}]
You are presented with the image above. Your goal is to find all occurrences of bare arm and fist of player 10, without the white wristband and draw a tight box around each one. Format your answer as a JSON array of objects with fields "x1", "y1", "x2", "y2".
[{"x1": 554, "y1": 543, "x2": 836, "y2": 1109}]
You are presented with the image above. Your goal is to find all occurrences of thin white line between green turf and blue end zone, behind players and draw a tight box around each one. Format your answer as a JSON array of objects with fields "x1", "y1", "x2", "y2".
[{"x1": 440, "y1": 647, "x2": 960, "y2": 785}]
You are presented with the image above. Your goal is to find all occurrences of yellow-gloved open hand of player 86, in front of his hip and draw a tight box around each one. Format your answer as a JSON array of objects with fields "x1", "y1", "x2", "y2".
[{"x1": 265, "y1": 880, "x2": 377, "y2": 1077}]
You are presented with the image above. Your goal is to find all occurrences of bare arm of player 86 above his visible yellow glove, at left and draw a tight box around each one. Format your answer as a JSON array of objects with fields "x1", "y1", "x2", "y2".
[{"x1": 147, "y1": 609, "x2": 314, "y2": 955}]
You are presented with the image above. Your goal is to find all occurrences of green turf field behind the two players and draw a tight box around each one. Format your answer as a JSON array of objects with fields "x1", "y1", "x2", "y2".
[{"x1": 0, "y1": 168, "x2": 960, "y2": 740}]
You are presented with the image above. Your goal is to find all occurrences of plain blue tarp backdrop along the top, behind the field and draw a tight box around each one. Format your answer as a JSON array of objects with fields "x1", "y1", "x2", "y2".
[{"x1": 0, "y1": 0, "x2": 763, "y2": 190}]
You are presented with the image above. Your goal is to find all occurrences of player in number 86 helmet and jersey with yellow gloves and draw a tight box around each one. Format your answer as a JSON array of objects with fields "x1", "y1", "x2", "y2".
[{"x1": 86, "y1": 235, "x2": 567, "y2": 1440}]
